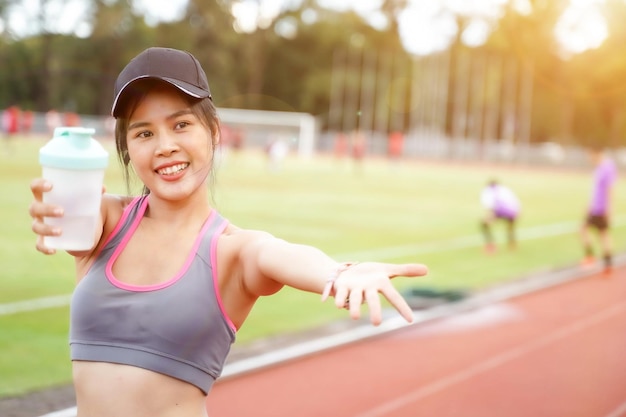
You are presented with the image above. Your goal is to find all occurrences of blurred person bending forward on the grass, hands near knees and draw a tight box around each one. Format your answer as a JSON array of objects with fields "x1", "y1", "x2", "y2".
[{"x1": 480, "y1": 179, "x2": 520, "y2": 253}]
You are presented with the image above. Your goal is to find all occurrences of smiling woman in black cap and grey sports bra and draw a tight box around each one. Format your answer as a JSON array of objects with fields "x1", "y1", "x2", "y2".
[{"x1": 30, "y1": 48, "x2": 427, "y2": 417}]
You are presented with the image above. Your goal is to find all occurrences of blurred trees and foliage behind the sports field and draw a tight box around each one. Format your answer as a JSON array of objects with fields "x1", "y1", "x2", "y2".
[{"x1": 0, "y1": 0, "x2": 626, "y2": 147}]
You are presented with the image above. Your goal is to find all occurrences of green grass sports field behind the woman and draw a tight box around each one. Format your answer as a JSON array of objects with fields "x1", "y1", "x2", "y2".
[{"x1": 0, "y1": 139, "x2": 626, "y2": 396}]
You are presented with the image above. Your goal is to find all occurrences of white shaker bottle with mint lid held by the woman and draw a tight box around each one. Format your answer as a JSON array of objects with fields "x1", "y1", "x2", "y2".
[{"x1": 39, "y1": 127, "x2": 109, "y2": 251}]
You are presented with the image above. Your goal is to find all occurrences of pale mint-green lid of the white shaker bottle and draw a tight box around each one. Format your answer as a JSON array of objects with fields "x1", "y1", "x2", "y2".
[{"x1": 39, "y1": 127, "x2": 109, "y2": 170}]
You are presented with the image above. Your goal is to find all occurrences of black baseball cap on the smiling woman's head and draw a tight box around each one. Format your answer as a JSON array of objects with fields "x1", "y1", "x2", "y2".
[{"x1": 111, "y1": 47, "x2": 211, "y2": 117}]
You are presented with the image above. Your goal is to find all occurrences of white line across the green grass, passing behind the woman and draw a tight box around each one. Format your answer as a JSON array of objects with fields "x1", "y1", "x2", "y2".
[{"x1": 7, "y1": 217, "x2": 626, "y2": 316}]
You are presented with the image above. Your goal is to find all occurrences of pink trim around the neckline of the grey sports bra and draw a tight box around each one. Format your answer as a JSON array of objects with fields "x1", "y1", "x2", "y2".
[{"x1": 106, "y1": 198, "x2": 216, "y2": 292}]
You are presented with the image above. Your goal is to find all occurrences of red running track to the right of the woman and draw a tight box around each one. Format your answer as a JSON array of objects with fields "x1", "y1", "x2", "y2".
[{"x1": 208, "y1": 269, "x2": 626, "y2": 417}]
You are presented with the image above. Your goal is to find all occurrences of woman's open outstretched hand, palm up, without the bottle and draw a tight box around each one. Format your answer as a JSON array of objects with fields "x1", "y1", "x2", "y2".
[{"x1": 322, "y1": 262, "x2": 428, "y2": 326}]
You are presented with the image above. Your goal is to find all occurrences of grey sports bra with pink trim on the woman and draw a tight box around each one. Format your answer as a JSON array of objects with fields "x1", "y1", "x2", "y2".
[{"x1": 70, "y1": 196, "x2": 236, "y2": 393}]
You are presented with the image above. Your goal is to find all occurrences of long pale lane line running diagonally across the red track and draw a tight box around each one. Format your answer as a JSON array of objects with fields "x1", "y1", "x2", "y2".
[{"x1": 358, "y1": 302, "x2": 626, "y2": 417}]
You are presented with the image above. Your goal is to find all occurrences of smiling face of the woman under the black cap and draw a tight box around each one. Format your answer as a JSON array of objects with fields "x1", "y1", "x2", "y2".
[{"x1": 126, "y1": 85, "x2": 213, "y2": 201}]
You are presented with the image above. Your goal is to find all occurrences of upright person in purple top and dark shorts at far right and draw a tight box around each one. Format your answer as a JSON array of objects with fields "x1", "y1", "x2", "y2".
[{"x1": 580, "y1": 148, "x2": 617, "y2": 273}]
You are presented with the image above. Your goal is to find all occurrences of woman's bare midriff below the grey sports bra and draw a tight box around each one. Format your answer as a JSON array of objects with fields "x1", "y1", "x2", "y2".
[{"x1": 72, "y1": 361, "x2": 207, "y2": 417}]
